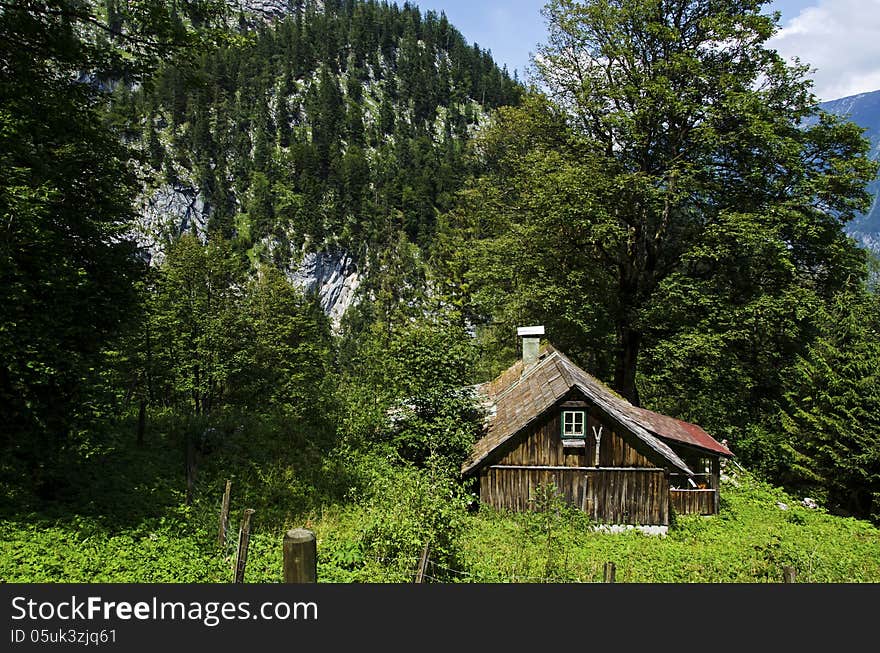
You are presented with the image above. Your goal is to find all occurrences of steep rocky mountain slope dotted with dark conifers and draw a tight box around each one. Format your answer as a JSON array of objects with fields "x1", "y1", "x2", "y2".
[{"x1": 123, "y1": 0, "x2": 522, "y2": 318}]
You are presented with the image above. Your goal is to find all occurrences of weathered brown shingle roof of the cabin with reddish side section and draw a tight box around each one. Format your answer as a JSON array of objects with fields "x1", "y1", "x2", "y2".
[{"x1": 461, "y1": 345, "x2": 732, "y2": 476}]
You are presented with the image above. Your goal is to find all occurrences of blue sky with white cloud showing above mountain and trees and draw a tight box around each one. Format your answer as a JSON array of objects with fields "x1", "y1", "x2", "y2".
[{"x1": 414, "y1": 0, "x2": 880, "y2": 100}]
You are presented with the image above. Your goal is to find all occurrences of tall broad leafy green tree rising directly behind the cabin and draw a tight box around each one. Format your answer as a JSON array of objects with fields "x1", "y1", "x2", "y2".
[{"x1": 442, "y1": 0, "x2": 875, "y2": 403}]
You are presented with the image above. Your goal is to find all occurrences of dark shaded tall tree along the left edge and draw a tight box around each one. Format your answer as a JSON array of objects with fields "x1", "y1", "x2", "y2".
[{"x1": 0, "y1": 0, "x2": 227, "y2": 486}]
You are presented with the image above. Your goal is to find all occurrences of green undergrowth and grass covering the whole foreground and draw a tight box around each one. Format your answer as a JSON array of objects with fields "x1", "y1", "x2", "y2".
[{"x1": 0, "y1": 416, "x2": 880, "y2": 583}]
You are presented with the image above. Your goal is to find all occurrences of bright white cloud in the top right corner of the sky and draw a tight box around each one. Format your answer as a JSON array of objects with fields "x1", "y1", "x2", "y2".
[{"x1": 768, "y1": 0, "x2": 880, "y2": 100}]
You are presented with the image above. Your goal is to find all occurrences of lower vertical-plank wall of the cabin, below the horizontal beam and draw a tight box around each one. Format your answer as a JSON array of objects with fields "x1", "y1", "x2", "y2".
[{"x1": 480, "y1": 466, "x2": 670, "y2": 526}]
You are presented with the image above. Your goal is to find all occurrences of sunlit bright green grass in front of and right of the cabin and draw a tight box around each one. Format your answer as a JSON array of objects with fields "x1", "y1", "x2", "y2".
[{"x1": 454, "y1": 468, "x2": 880, "y2": 583}]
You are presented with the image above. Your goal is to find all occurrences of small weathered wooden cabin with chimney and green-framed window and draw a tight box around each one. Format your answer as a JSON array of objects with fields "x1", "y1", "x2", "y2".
[{"x1": 461, "y1": 327, "x2": 733, "y2": 526}]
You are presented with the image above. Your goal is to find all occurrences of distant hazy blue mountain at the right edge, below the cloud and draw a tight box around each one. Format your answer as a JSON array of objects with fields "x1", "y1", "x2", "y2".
[{"x1": 820, "y1": 86, "x2": 880, "y2": 254}]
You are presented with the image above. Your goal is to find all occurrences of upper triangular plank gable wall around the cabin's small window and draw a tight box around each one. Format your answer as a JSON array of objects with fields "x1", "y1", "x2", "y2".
[{"x1": 496, "y1": 409, "x2": 656, "y2": 467}]
